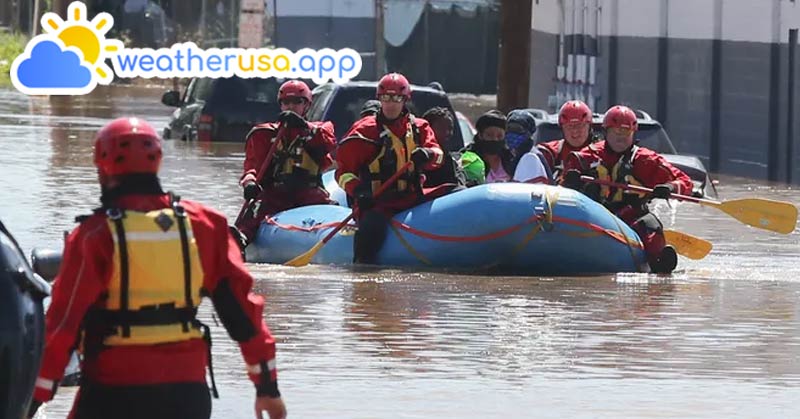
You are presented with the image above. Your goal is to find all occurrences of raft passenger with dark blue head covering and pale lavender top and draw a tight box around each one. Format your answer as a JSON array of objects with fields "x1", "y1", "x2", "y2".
[{"x1": 506, "y1": 109, "x2": 553, "y2": 184}]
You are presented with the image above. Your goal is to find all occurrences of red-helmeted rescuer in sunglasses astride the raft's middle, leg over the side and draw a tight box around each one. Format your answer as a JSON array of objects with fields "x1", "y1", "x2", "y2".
[{"x1": 335, "y1": 73, "x2": 444, "y2": 264}]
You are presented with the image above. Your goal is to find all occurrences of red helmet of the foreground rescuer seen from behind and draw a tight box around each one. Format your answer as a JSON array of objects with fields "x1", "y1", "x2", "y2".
[{"x1": 94, "y1": 118, "x2": 162, "y2": 176}]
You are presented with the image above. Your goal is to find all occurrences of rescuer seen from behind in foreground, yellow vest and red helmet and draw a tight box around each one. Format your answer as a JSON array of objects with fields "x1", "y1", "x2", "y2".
[{"x1": 29, "y1": 118, "x2": 286, "y2": 419}]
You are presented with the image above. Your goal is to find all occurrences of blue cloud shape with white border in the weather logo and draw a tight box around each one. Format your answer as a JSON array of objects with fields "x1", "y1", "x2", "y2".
[{"x1": 11, "y1": 39, "x2": 96, "y2": 94}]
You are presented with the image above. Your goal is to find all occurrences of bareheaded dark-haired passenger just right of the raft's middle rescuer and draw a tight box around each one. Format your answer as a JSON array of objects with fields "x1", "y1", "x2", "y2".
[{"x1": 422, "y1": 107, "x2": 467, "y2": 192}]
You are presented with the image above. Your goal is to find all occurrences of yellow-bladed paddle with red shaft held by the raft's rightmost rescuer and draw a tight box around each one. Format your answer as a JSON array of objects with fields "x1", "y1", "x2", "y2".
[{"x1": 581, "y1": 176, "x2": 797, "y2": 234}]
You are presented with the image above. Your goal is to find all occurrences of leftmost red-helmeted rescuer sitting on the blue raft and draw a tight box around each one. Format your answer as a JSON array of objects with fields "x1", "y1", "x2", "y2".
[{"x1": 236, "y1": 80, "x2": 336, "y2": 248}]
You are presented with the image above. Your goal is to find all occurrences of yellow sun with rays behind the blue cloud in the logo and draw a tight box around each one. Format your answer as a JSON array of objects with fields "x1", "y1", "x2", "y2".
[{"x1": 42, "y1": 1, "x2": 124, "y2": 84}]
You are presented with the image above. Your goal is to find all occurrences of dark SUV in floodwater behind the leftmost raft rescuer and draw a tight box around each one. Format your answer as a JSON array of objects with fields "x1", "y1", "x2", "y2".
[{"x1": 161, "y1": 76, "x2": 282, "y2": 142}]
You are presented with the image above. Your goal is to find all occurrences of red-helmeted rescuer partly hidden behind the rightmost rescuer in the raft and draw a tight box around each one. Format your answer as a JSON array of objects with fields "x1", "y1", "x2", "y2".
[{"x1": 536, "y1": 100, "x2": 594, "y2": 180}]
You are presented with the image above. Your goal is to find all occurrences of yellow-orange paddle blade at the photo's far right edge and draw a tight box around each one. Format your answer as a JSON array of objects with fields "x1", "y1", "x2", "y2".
[{"x1": 704, "y1": 198, "x2": 797, "y2": 234}]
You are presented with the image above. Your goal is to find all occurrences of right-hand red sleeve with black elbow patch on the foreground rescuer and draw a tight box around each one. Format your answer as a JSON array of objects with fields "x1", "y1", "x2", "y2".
[{"x1": 190, "y1": 201, "x2": 278, "y2": 395}]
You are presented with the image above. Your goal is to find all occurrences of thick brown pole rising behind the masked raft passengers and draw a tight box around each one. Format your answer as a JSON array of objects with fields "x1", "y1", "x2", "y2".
[{"x1": 497, "y1": 0, "x2": 533, "y2": 112}]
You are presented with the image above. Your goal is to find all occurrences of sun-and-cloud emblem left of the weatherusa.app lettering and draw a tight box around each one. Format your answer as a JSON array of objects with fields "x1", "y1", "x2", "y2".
[{"x1": 11, "y1": 2, "x2": 123, "y2": 95}]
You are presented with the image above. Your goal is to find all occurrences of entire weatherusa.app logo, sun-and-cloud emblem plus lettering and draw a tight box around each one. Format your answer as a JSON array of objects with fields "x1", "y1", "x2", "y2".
[{"x1": 11, "y1": 1, "x2": 361, "y2": 95}]
